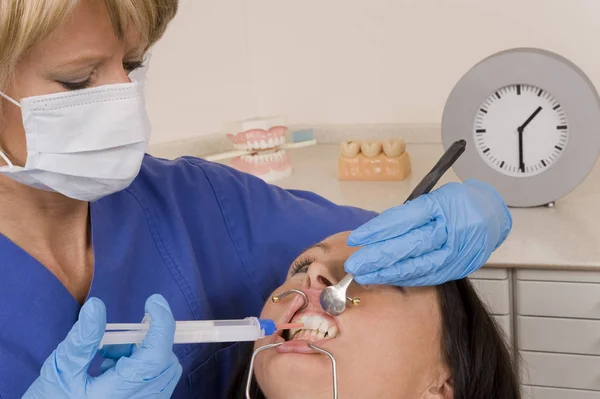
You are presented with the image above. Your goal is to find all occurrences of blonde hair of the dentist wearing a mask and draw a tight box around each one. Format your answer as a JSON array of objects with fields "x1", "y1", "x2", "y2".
[{"x1": 0, "y1": 0, "x2": 178, "y2": 90}]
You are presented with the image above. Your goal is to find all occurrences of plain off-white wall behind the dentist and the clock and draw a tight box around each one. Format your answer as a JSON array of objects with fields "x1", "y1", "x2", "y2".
[{"x1": 148, "y1": 0, "x2": 600, "y2": 143}]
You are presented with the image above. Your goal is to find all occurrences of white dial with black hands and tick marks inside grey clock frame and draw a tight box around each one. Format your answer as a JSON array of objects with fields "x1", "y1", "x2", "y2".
[{"x1": 473, "y1": 84, "x2": 569, "y2": 177}]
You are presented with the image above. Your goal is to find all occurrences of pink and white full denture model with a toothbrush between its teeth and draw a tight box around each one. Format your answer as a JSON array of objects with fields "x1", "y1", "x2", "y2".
[{"x1": 227, "y1": 119, "x2": 292, "y2": 182}]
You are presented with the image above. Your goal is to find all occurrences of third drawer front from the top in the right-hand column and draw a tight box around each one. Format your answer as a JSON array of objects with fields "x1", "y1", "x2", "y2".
[{"x1": 519, "y1": 351, "x2": 600, "y2": 391}]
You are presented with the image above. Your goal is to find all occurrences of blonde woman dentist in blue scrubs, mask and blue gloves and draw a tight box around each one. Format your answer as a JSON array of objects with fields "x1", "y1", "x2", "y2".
[{"x1": 0, "y1": 0, "x2": 512, "y2": 399}]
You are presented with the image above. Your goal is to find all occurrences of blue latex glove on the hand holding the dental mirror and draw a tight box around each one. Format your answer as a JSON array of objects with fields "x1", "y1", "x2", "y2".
[{"x1": 345, "y1": 180, "x2": 512, "y2": 286}]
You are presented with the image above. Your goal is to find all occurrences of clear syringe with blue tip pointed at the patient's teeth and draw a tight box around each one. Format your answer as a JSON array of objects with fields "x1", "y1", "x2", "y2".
[{"x1": 100, "y1": 317, "x2": 304, "y2": 348}]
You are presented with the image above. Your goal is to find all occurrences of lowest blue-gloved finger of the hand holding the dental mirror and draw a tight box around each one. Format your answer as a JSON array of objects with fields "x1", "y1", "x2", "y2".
[{"x1": 354, "y1": 246, "x2": 452, "y2": 286}]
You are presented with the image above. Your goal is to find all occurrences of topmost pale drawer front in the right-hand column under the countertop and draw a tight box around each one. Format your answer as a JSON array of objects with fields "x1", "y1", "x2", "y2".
[{"x1": 516, "y1": 281, "x2": 600, "y2": 319}]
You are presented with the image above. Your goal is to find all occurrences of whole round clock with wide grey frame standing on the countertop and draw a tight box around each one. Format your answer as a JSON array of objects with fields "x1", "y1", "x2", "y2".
[{"x1": 442, "y1": 48, "x2": 600, "y2": 207}]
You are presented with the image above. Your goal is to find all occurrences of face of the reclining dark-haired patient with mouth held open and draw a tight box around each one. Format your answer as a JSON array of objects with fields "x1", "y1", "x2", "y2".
[{"x1": 255, "y1": 233, "x2": 452, "y2": 399}]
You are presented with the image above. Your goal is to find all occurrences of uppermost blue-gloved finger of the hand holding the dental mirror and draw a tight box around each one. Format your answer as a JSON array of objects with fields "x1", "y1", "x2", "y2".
[{"x1": 347, "y1": 195, "x2": 439, "y2": 246}]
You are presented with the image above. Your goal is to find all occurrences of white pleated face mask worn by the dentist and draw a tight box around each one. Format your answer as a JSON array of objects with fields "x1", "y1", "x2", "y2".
[{"x1": 0, "y1": 82, "x2": 151, "y2": 201}]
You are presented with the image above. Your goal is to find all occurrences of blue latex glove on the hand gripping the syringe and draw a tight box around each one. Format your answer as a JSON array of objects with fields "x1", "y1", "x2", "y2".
[{"x1": 23, "y1": 295, "x2": 182, "y2": 399}]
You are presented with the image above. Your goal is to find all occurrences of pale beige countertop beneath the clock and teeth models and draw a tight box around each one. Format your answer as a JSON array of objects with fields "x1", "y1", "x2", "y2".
[{"x1": 225, "y1": 144, "x2": 600, "y2": 270}]
